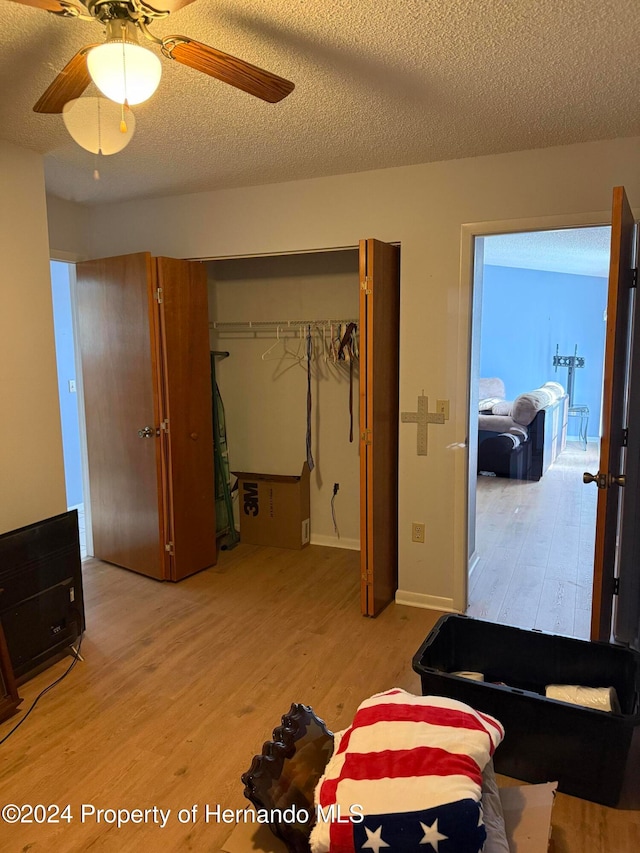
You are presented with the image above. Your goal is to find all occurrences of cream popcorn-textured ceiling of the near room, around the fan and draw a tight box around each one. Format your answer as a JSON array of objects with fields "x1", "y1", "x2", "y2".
[{"x1": 0, "y1": 0, "x2": 640, "y2": 203}]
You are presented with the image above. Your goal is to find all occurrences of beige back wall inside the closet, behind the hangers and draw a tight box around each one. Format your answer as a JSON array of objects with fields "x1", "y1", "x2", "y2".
[{"x1": 208, "y1": 249, "x2": 360, "y2": 549}]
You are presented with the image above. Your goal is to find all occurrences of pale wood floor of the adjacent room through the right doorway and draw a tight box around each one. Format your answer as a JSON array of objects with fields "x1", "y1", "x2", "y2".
[{"x1": 467, "y1": 441, "x2": 598, "y2": 639}]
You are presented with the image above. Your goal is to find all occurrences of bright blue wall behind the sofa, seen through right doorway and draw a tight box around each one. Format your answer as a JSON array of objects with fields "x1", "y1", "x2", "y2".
[{"x1": 480, "y1": 264, "x2": 607, "y2": 437}]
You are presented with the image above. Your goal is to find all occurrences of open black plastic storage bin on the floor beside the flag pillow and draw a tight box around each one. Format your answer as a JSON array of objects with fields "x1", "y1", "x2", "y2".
[{"x1": 413, "y1": 615, "x2": 640, "y2": 806}]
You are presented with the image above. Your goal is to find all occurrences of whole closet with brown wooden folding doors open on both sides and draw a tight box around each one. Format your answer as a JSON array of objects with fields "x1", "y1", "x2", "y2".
[{"x1": 72, "y1": 240, "x2": 400, "y2": 604}]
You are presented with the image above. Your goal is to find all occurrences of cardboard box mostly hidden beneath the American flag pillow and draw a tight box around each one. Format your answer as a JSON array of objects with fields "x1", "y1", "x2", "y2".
[{"x1": 222, "y1": 782, "x2": 556, "y2": 853}]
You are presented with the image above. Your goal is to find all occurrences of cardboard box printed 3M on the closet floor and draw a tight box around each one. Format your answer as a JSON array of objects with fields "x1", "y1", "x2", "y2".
[{"x1": 233, "y1": 462, "x2": 311, "y2": 549}]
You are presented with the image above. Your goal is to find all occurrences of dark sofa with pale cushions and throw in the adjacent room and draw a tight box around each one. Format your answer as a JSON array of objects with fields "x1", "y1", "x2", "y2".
[{"x1": 478, "y1": 377, "x2": 569, "y2": 480}]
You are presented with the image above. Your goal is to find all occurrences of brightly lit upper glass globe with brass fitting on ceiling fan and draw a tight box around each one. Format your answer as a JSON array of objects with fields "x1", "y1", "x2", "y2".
[{"x1": 87, "y1": 21, "x2": 162, "y2": 105}]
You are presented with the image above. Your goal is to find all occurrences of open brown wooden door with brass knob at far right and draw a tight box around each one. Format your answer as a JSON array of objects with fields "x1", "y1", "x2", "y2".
[{"x1": 583, "y1": 187, "x2": 637, "y2": 642}]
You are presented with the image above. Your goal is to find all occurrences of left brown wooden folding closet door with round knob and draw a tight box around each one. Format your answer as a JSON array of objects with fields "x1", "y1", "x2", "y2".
[{"x1": 76, "y1": 253, "x2": 216, "y2": 581}]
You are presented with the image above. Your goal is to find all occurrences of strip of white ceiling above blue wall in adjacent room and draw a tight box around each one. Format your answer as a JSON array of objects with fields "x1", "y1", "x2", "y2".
[{"x1": 484, "y1": 226, "x2": 611, "y2": 278}]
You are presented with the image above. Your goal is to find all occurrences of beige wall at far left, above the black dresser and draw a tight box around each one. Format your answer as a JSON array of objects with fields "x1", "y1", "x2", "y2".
[{"x1": 0, "y1": 142, "x2": 66, "y2": 532}]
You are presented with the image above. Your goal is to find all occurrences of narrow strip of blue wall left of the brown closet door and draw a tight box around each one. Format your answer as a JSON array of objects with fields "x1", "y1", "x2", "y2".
[{"x1": 51, "y1": 261, "x2": 82, "y2": 506}]
